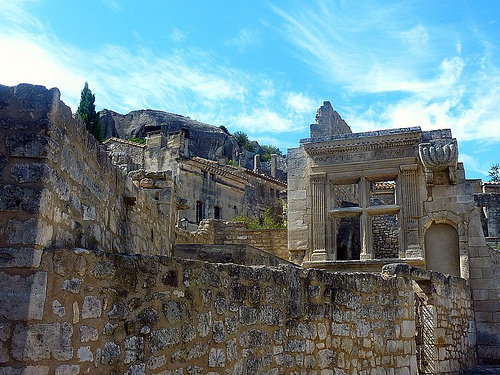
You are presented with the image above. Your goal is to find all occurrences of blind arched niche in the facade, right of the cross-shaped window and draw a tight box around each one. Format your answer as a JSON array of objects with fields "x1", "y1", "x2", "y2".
[{"x1": 425, "y1": 224, "x2": 460, "y2": 276}]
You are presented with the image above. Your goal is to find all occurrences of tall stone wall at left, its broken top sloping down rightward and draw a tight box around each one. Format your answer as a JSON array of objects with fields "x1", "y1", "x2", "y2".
[{"x1": 0, "y1": 85, "x2": 171, "y2": 258}]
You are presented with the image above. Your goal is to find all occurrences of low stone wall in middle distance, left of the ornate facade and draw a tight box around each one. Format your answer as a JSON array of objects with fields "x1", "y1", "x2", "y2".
[{"x1": 175, "y1": 219, "x2": 290, "y2": 260}]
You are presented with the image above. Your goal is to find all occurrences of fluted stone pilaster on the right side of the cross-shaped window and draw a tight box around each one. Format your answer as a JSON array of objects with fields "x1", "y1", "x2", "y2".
[{"x1": 396, "y1": 164, "x2": 423, "y2": 258}]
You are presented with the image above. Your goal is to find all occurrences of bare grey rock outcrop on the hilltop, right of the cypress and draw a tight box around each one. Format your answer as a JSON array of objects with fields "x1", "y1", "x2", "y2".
[{"x1": 100, "y1": 109, "x2": 239, "y2": 160}]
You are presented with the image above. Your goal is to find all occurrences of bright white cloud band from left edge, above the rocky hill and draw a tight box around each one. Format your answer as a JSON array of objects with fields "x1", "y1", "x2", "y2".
[{"x1": 0, "y1": 1, "x2": 304, "y2": 141}]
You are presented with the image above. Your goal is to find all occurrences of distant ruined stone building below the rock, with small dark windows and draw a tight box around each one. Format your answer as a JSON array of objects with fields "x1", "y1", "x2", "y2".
[{"x1": 104, "y1": 131, "x2": 286, "y2": 230}]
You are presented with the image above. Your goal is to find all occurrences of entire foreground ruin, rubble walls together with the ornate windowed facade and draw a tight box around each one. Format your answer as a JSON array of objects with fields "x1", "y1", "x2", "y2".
[{"x1": 0, "y1": 85, "x2": 500, "y2": 375}]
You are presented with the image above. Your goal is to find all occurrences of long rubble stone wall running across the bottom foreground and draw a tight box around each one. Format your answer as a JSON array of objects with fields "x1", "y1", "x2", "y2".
[{"x1": 0, "y1": 249, "x2": 474, "y2": 375}]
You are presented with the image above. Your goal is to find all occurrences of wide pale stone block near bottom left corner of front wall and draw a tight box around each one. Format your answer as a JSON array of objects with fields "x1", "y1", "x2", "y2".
[{"x1": 11, "y1": 323, "x2": 73, "y2": 361}]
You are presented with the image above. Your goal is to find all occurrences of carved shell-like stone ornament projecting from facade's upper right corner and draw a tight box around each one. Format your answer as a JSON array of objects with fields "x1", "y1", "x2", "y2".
[{"x1": 418, "y1": 139, "x2": 458, "y2": 186}]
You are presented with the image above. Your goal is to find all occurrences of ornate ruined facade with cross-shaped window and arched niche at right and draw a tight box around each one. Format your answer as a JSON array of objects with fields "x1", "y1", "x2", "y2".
[{"x1": 288, "y1": 102, "x2": 500, "y2": 366}]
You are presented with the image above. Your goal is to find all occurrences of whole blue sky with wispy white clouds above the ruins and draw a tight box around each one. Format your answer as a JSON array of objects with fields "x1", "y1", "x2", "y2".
[{"x1": 0, "y1": 0, "x2": 500, "y2": 179}]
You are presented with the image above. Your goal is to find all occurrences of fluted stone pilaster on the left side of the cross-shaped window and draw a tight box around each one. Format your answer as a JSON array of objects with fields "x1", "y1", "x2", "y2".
[{"x1": 311, "y1": 173, "x2": 327, "y2": 261}]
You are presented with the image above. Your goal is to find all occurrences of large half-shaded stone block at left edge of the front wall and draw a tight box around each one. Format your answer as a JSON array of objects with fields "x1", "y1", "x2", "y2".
[{"x1": 0, "y1": 272, "x2": 47, "y2": 320}]
